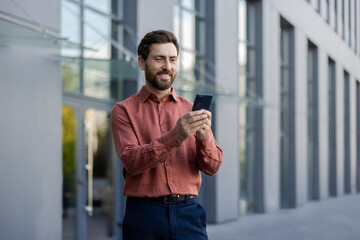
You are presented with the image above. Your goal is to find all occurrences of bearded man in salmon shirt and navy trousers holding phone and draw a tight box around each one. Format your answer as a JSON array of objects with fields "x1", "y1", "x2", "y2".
[{"x1": 111, "y1": 30, "x2": 222, "y2": 240}]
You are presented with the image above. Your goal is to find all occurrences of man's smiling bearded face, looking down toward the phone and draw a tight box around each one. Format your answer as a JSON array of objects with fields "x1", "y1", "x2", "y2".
[{"x1": 139, "y1": 43, "x2": 177, "y2": 90}]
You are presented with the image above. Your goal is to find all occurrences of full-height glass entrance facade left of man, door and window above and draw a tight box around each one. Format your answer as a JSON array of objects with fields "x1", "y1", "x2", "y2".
[{"x1": 60, "y1": 0, "x2": 139, "y2": 239}]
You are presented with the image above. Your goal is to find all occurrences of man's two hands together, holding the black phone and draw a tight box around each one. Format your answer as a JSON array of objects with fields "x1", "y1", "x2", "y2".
[{"x1": 174, "y1": 110, "x2": 211, "y2": 142}]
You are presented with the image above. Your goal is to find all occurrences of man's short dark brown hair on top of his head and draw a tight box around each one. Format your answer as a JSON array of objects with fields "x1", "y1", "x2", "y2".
[{"x1": 137, "y1": 30, "x2": 179, "y2": 60}]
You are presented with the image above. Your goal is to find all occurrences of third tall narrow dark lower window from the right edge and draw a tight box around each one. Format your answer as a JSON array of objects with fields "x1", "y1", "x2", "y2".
[{"x1": 328, "y1": 58, "x2": 337, "y2": 196}]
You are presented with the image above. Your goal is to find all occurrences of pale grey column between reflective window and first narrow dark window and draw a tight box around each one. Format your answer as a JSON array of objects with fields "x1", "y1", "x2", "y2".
[{"x1": 263, "y1": 1, "x2": 280, "y2": 212}]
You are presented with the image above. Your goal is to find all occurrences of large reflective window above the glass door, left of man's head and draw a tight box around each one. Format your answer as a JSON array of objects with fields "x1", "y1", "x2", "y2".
[{"x1": 61, "y1": 0, "x2": 138, "y2": 99}]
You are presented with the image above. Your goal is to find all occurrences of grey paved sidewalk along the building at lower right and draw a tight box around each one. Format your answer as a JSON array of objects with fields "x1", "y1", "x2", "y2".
[{"x1": 207, "y1": 194, "x2": 360, "y2": 240}]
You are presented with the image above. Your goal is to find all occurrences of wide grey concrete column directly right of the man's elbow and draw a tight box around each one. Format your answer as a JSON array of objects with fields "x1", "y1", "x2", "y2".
[{"x1": 209, "y1": 0, "x2": 240, "y2": 222}]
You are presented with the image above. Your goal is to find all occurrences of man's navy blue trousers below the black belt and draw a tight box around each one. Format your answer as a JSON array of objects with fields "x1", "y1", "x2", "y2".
[{"x1": 122, "y1": 198, "x2": 208, "y2": 240}]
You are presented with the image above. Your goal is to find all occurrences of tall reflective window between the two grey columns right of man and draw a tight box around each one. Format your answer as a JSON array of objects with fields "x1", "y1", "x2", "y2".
[{"x1": 238, "y1": 0, "x2": 263, "y2": 214}]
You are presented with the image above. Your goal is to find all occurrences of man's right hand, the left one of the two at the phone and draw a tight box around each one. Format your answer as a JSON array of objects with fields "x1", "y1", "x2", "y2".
[{"x1": 174, "y1": 110, "x2": 210, "y2": 142}]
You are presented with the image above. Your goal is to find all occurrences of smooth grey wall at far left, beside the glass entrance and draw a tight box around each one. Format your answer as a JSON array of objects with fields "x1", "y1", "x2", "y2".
[{"x1": 0, "y1": 0, "x2": 62, "y2": 240}]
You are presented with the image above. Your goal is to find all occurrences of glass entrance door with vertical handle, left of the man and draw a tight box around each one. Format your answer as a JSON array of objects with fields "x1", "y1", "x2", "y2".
[{"x1": 62, "y1": 106, "x2": 117, "y2": 240}]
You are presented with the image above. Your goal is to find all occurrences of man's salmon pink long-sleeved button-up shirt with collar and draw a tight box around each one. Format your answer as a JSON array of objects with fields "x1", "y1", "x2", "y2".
[{"x1": 111, "y1": 86, "x2": 223, "y2": 197}]
